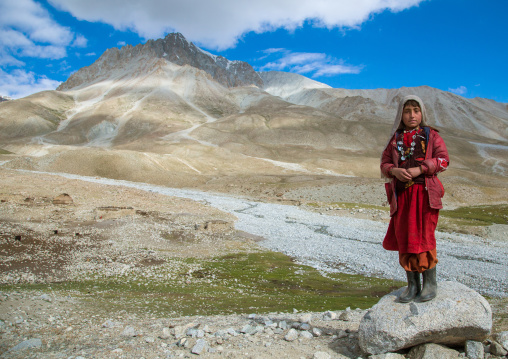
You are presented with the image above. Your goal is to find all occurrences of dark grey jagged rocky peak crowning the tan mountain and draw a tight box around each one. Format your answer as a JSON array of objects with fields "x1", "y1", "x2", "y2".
[{"x1": 58, "y1": 33, "x2": 263, "y2": 91}]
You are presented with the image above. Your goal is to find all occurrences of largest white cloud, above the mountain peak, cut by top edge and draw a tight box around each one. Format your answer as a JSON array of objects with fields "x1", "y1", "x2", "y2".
[{"x1": 47, "y1": 0, "x2": 424, "y2": 50}]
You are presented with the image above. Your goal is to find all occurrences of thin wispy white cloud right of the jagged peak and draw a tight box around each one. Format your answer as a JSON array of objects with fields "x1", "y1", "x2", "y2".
[{"x1": 257, "y1": 49, "x2": 362, "y2": 77}]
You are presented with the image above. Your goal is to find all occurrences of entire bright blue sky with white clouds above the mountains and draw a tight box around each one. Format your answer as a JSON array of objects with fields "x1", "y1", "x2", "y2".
[{"x1": 0, "y1": 0, "x2": 508, "y2": 103}]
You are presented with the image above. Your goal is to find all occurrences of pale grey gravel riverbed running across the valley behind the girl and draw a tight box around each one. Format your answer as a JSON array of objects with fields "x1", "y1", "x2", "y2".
[{"x1": 19, "y1": 173, "x2": 508, "y2": 297}]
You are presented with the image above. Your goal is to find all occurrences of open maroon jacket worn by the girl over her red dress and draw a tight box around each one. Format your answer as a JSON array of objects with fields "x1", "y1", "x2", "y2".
[{"x1": 381, "y1": 127, "x2": 450, "y2": 216}]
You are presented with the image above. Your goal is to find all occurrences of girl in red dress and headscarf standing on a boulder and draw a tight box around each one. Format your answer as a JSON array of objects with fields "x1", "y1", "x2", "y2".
[{"x1": 381, "y1": 96, "x2": 449, "y2": 303}]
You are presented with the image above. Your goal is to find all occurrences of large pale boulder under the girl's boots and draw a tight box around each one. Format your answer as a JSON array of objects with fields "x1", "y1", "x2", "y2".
[{"x1": 358, "y1": 282, "x2": 492, "y2": 354}]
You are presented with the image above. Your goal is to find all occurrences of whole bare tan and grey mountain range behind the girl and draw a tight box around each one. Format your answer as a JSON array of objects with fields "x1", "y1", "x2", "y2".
[{"x1": 0, "y1": 34, "x2": 508, "y2": 207}]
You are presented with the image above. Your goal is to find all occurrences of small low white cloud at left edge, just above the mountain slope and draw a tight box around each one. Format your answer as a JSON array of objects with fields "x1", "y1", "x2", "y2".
[{"x1": 0, "y1": 69, "x2": 61, "y2": 99}]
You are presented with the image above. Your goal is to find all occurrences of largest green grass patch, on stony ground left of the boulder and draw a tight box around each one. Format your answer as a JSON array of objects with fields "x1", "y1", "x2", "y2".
[{"x1": 2, "y1": 251, "x2": 404, "y2": 315}]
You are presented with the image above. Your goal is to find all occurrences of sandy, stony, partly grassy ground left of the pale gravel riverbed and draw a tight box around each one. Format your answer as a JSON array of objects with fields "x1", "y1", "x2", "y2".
[{"x1": 0, "y1": 167, "x2": 508, "y2": 358}]
